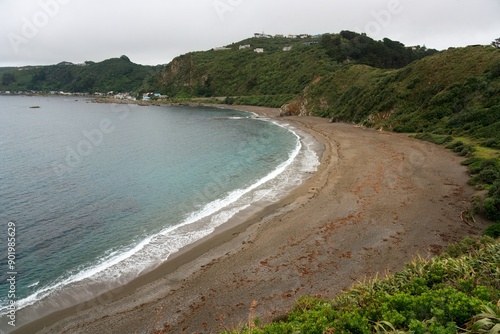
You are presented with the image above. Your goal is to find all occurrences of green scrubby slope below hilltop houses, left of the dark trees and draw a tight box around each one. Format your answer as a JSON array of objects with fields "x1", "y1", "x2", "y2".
[{"x1": 156, "y1": 38, "x2": 339, "y2": 102}]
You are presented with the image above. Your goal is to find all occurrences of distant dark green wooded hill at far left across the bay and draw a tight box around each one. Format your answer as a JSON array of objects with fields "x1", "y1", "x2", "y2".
[{"x1": 0, "y1": 56, "x2": 156, "y2": 93}]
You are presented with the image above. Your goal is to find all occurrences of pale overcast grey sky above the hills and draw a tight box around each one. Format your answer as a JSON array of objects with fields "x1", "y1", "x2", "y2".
[{"x1": 0, "y1": 0, "x2": 500, "y2": 67}]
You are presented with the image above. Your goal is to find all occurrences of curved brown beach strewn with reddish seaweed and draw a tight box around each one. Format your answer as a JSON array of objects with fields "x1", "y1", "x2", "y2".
[{"x1": 19, "y1": 106, "x2": 485, "y2": 333}]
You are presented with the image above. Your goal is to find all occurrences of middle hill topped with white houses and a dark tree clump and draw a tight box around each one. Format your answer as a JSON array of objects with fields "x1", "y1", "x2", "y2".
[{"x1": 150, "y1": 31, "x2": 435, "y2": 106}]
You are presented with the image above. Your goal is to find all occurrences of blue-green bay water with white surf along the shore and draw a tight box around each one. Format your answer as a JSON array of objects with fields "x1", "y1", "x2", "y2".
[{"x1": 0, "y1": 96, "x2": 319, "y2": 330}]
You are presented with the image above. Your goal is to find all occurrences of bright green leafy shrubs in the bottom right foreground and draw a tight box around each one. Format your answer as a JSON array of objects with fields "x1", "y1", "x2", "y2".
[{"x1": 229, "y1": 237, "x2": 500, "y2": 334}]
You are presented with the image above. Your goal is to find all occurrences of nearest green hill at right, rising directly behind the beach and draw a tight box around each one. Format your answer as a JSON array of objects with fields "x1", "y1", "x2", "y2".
[{"x1": 289, "y1": 46, "x2": 500, "y2": 148}]
